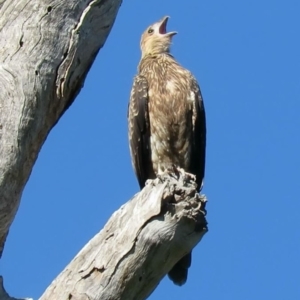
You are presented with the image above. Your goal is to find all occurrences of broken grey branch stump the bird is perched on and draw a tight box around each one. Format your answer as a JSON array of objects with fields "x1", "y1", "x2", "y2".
[{"x1": 0, "y1": 174, "x2": 207, "y2": 300}]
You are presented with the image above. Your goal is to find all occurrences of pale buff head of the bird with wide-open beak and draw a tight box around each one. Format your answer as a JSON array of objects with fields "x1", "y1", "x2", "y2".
[{"x1": 141, "y1": 16, "x2": 177, "y2": 57}]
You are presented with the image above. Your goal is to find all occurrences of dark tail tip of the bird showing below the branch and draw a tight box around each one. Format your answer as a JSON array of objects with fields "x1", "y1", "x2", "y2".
[{"x1": 168, "y1": 252, "x2": 192, "y2": 286}]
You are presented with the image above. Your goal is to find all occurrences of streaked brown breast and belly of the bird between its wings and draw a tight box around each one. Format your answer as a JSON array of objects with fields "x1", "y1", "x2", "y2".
[{"x1": 149, "y1": 78, "x2": 192, "y2": 173}]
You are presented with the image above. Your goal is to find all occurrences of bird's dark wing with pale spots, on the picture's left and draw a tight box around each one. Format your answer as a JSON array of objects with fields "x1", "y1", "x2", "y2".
[{"x1": 128, "y1": 75, "x2": 151, "y2": 189}]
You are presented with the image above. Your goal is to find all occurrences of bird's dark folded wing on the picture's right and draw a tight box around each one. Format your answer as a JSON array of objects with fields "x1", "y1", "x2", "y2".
[{"x1": 191, "y1": 76, "x2": 206, "y2": 190}]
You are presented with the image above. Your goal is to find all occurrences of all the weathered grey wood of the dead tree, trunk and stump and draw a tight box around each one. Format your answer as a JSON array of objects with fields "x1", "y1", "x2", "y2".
[{"x1": 0, "y1": 0, "x2": 207, "y2": 300}]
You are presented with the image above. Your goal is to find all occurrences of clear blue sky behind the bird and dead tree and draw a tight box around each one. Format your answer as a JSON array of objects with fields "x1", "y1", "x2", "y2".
[{"x1": 1, "y1": 0, "x2": 300, "y2": 300}]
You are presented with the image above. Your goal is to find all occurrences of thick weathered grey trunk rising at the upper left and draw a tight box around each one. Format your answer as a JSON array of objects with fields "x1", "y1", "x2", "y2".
[{"x1": 0, "y1": 0, "x2": 121, "y2": 256}]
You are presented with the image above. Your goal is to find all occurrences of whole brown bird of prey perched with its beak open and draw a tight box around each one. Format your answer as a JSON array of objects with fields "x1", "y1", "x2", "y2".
[{"x1": 128, "y1": 16, "x2": 206, "y2": 286}]
